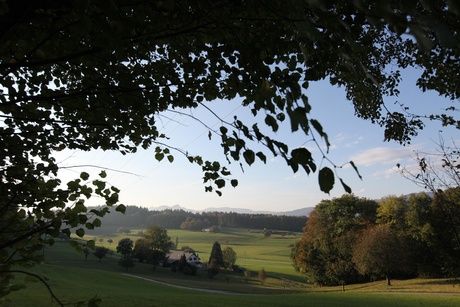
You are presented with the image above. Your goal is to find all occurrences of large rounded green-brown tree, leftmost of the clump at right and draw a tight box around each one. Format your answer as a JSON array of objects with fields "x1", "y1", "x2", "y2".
[{"x1": 292, "y1": 195, "x2": 377, "y2": 285}]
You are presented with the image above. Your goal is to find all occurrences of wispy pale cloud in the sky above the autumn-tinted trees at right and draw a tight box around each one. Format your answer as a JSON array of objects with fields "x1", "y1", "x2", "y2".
[{"x1": 351, "y1": 147, "x2": 413, "y2": 166}]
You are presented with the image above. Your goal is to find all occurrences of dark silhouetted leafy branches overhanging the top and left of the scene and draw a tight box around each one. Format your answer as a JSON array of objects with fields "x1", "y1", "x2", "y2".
[{"x1": 0, "y1": 0, "x2": 460, "y2": 300}]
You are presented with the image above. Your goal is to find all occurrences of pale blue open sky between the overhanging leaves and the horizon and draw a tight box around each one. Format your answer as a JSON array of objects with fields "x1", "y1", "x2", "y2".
[{"x1": 56, "y1": 70, "x2": 459, "y2": 211}]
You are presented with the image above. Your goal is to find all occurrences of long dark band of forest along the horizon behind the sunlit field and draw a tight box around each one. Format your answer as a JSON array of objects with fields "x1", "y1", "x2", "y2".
[{"x1": 94, "y1": 206, "x2": 307, "y2": 232}]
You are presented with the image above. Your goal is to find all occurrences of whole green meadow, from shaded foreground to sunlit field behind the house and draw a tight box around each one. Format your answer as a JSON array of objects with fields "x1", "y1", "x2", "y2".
[{"x1": 0, "y1": 230, "x2": 460, "y2": 307}]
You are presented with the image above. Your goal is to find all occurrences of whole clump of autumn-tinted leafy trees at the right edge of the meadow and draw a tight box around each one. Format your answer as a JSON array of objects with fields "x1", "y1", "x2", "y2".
[{"x1": 292, "y1": 188, "x2": 460, "y2": 285}]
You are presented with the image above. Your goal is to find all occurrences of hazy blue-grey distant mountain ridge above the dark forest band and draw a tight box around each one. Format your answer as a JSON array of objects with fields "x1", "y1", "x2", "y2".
[{"x1": 149, "y1": 205, "x2": 315, "y2": 216}]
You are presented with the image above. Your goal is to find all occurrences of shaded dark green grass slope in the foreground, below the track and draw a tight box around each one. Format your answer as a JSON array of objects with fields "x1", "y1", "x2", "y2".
[{"x1": 4, "y1": 265, "x2": 460, "y2": 307}]
